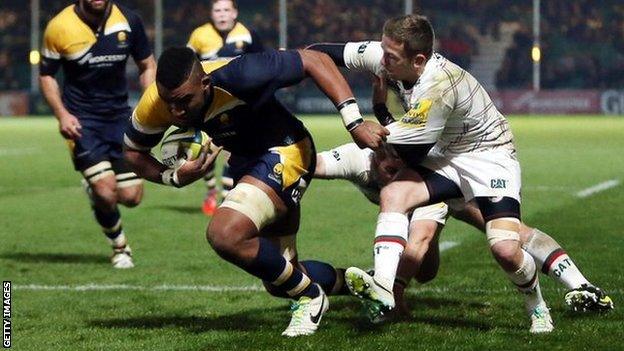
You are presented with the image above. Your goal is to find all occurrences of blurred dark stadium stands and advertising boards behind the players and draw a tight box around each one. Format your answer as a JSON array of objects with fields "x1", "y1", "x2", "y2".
[{"x1": 0, "y1": 0, "x2": 624, "y2": 115}]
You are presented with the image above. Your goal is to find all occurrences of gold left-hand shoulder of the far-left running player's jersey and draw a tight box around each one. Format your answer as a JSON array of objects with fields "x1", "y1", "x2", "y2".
[{"x1": 42, "y1": 5, "x2": 97, "y2": 60}]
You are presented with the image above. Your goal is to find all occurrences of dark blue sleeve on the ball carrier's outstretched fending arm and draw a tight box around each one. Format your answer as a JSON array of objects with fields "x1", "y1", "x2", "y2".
[{"x1": 213, "y1": 50, "x2": 306, "y2": 106}]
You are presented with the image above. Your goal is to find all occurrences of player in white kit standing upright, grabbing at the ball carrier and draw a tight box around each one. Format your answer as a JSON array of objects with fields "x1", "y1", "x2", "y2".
[{"x1": 308, "y1": 15, "x2": 554, "y2": 333}]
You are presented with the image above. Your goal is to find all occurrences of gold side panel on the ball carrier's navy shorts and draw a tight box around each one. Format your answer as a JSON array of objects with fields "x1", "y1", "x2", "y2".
[{"x1": 270, "y1": 138, "x2": 314, "y2": 189}]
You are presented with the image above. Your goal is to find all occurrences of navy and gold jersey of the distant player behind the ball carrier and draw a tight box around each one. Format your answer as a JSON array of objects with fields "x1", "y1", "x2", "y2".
[{"x1": 186, "y1": 22, "x2": 264, "y2": 60}]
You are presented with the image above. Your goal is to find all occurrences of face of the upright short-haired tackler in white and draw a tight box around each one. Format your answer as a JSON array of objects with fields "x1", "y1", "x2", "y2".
[{"x1": 381, "y1": 35, "x2": 418, "y2": 81}]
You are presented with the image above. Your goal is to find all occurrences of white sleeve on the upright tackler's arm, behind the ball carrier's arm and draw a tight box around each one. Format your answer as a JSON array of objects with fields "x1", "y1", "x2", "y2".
[{"x1": 343, "y1": 41, "x2": 383, "y2": 76}]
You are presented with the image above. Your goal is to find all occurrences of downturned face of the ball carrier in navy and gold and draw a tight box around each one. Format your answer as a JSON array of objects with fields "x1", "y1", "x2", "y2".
[{"x1": 157, "y1": 64, "x2": 210, "y2": 127}]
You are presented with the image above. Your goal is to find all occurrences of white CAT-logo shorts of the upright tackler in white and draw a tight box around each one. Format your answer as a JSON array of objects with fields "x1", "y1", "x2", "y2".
[{"x1": 422, "y1": 150, "x2": 522, "y2": 202}]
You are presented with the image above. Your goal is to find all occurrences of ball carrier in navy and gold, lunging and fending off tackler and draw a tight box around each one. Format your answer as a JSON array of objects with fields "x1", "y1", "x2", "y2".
[{"x1": 124, "y1": 48, "x2": 387, "y2": 336}]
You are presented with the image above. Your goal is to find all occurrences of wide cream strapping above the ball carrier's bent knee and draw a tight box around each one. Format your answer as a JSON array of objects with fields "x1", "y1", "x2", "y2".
[{"x1": 221, "y1": 183, "x2": 277, "y2": 230}]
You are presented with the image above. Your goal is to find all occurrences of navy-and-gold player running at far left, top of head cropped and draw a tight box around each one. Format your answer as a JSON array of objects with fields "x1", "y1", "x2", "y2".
[{"x1": 39, "y1": 0, "x2": 156, "y2": 268}]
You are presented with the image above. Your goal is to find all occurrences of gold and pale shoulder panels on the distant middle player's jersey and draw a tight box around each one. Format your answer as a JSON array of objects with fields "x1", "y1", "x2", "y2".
[{"x1": 186, "y1": 23, "x2": 251, "y2": 59}]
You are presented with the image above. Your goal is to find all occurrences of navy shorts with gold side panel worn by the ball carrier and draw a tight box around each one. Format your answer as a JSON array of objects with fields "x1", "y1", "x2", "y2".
[{"x1": 229, "y1": 137, "x2": 316, "y2": 208}]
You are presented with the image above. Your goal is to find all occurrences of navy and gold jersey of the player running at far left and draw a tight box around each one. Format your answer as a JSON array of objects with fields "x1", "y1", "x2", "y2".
[{"x1": 40, "y1": 3, "x2": 151, "y2": 118}]
